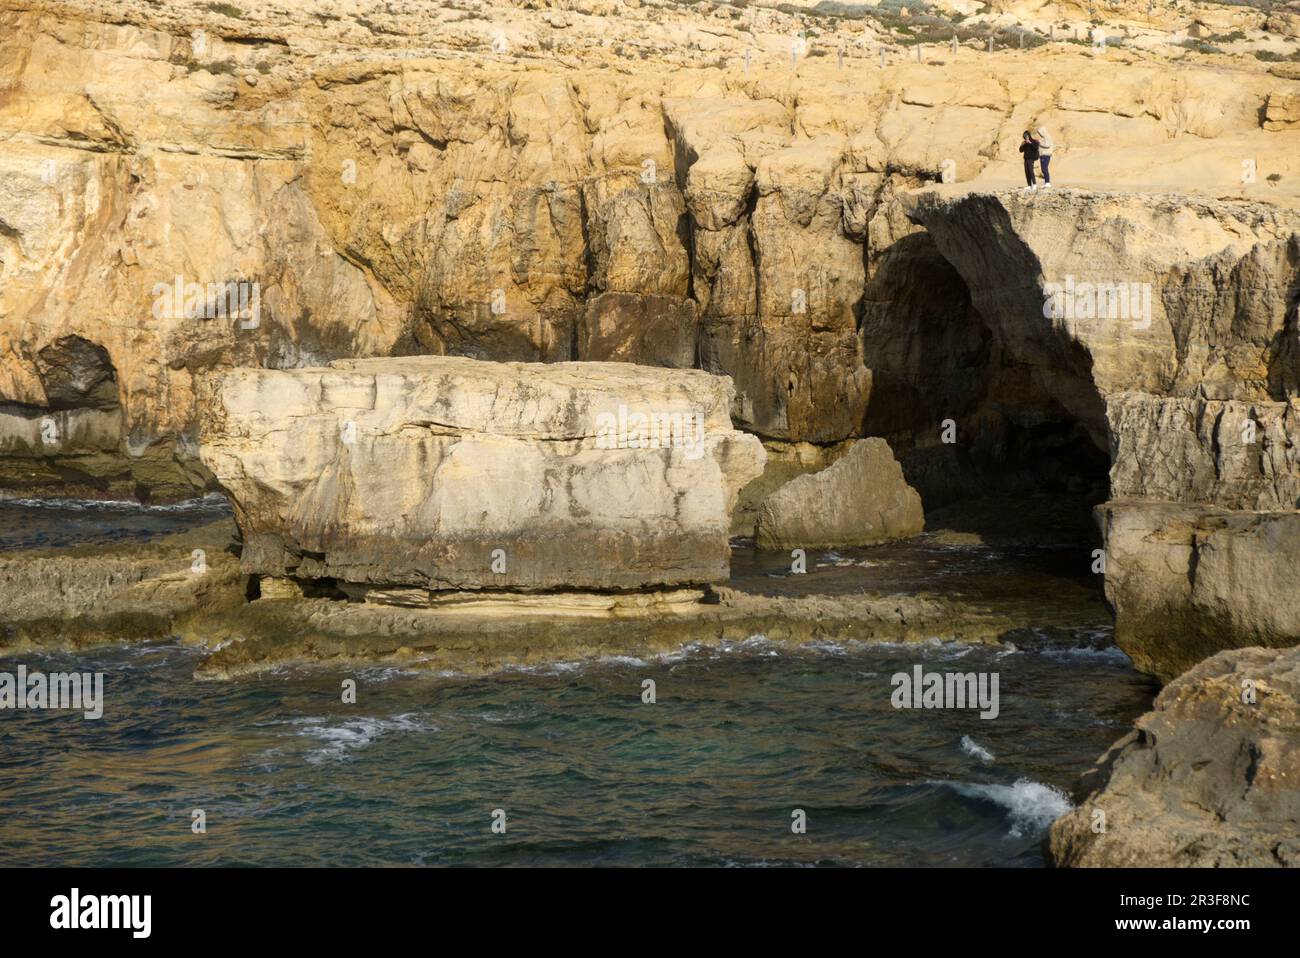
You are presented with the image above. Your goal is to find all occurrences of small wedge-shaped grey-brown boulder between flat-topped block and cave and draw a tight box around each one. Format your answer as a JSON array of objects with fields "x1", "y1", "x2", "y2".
[{"x1": 755, "y1": 438, "x2": 926, "y2": 549}]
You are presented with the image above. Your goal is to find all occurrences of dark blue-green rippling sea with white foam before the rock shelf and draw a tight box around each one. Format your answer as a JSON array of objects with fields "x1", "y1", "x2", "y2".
[{"x1": 0, "y1": 496, "x2": 1153, "y2": 867}]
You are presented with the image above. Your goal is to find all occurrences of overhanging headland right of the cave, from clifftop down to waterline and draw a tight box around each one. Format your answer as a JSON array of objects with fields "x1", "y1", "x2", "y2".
[{"x1": 913, "y1": 190, "x2": 1300, "y2": 679}]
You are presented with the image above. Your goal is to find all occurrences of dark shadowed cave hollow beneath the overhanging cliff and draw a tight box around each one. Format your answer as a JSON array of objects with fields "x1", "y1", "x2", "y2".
[{"x1": 859, "y1": 231, "x2": 1110, "y2": 549}]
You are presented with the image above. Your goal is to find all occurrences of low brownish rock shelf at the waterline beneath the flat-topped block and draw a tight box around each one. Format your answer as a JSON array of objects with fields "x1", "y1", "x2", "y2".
[{"x1": 0, "y1": 496, "x2": 1106, "y2": 679}]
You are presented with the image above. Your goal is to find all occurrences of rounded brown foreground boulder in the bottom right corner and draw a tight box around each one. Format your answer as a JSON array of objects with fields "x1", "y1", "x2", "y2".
[{"x1": 1047, "y1": 649, "x2": 1300, "y2": 868}]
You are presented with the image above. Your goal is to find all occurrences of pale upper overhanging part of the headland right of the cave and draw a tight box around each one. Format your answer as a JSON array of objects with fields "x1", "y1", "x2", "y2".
[{"x1": 911, "y1": 190, "x2": 1300, "y2": 448}]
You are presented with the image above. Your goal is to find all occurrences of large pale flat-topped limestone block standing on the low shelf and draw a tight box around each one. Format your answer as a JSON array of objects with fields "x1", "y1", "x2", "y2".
[{"x1": 202, "y1": 356, "x2": 764, "y2": 590}]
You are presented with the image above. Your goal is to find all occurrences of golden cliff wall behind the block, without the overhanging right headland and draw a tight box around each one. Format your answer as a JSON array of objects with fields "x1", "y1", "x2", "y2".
[{"x1": 0, "y1": 0, "x2": 1300, "y2": 497}]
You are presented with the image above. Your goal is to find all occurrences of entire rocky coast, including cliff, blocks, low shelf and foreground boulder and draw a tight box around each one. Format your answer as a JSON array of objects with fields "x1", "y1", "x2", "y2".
[{"x1": 0, "y1": 0, "x2": 1300, "y2": 866}]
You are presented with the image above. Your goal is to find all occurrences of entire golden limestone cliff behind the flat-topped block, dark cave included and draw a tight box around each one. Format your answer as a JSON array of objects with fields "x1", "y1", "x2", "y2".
[{"x1": 0, "y1": 0, "x2": 1300, "y2": 677}]
